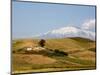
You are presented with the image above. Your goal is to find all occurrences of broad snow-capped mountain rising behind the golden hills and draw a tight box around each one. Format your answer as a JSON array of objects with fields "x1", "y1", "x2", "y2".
[{"x1": 36, "y1": 26, "x2": 95, "y2": 40}]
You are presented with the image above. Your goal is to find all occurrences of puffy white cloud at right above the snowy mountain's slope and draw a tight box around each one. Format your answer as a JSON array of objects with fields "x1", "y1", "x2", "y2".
[{"x1": 81, "y1": 19, "x2": 95, "y2": 30}]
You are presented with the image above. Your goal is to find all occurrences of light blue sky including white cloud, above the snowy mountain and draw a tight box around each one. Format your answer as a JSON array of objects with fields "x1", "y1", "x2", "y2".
[{"x1": 12, "y1": 1, "x2": 95, "y2": 38}]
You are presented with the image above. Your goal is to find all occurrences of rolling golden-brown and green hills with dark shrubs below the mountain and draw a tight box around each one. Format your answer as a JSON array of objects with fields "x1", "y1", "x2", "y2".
[{"x1": 12, "y1": 37, "x2": 96, "y2": 73}]
